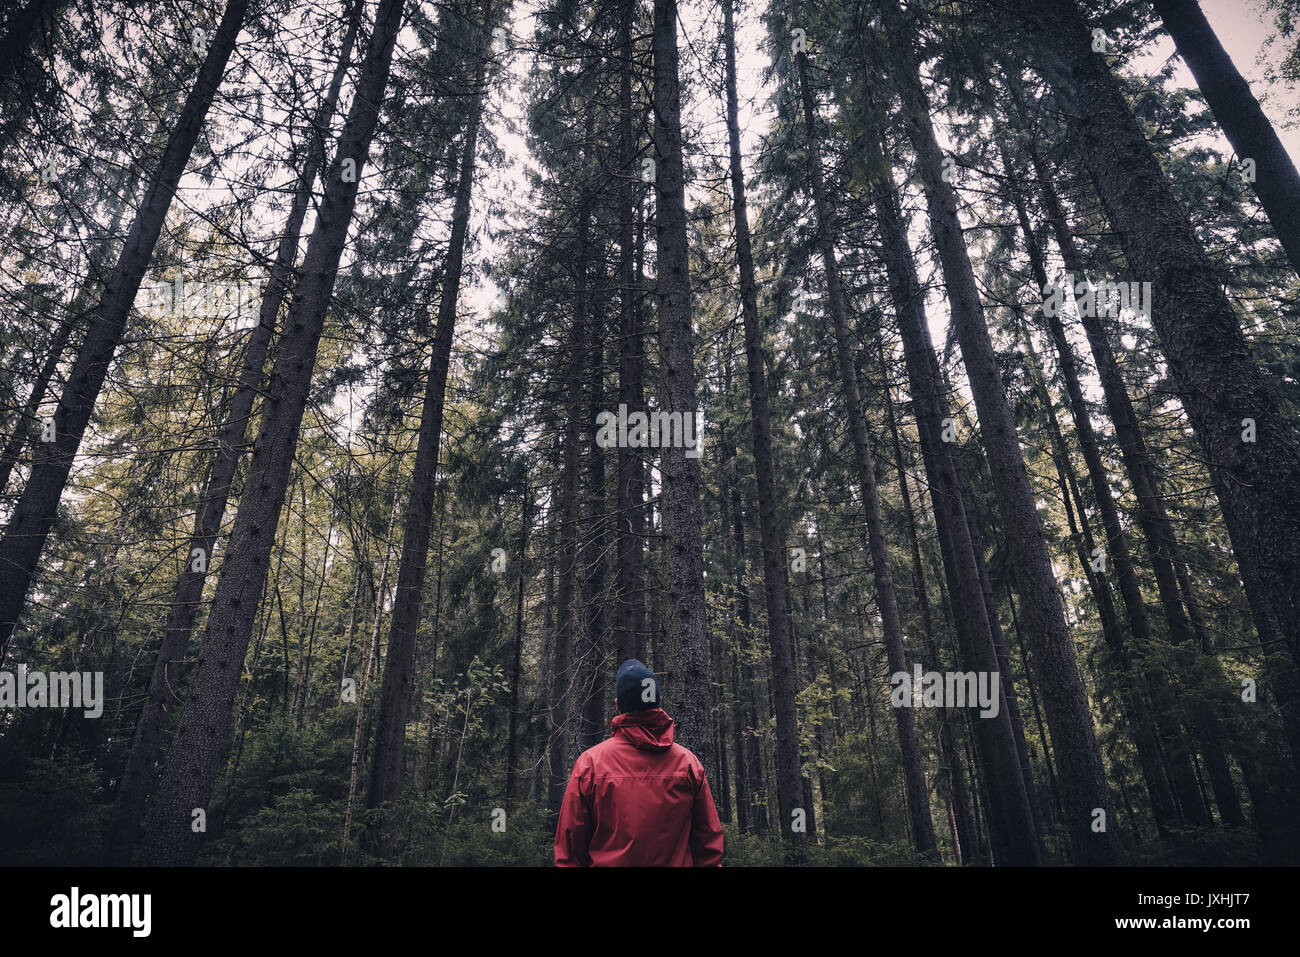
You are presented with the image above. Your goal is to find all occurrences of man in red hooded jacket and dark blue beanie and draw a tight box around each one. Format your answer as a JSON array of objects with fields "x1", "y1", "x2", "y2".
[{"x1": 555, "y1": 658, "x2": 723, "y2": 867}]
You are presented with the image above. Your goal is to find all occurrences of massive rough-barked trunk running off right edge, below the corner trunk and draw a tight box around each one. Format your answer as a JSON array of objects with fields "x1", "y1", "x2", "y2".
[{"x1": 1011, "y1": 0, "x2": 1300, "y2": 691}]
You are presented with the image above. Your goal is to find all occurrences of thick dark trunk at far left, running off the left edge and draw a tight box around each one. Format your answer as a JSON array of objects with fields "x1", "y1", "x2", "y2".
[{"x1": 0, "y1": 0, "x2": 248, "y2": 659}]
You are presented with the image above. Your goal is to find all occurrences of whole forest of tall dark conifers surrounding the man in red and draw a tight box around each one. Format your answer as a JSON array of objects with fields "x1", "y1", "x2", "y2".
[{"x1": 0, "y1": 0, "x2": 1300, "y2": 865}]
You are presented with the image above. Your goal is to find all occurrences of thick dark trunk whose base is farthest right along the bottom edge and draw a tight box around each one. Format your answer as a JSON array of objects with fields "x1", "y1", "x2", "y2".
[{"x1": 881, "y1": 0, "x2": 1119, "y2": 865}]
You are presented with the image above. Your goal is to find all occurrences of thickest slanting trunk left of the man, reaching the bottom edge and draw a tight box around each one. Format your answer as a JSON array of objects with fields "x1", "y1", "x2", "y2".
[{"x1": 144, "y1": 0, "x2": 403, "y2": 865}]
